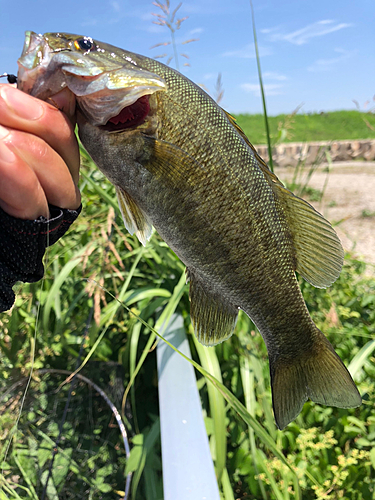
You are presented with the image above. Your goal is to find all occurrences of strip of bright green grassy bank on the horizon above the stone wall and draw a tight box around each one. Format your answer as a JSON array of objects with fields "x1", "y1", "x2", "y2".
[{"x1": 236, "y1": 111, "x2": 375, "y2": 144}]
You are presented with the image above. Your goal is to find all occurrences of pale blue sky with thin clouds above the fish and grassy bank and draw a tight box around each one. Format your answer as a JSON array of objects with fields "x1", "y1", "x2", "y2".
[{"x1": 0, "y1": 0, "x2": 375, "y2": 115}]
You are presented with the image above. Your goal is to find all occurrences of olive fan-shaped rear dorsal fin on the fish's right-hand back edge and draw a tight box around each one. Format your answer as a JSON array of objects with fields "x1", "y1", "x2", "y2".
[{"x1": 272, "y1": 183, "x2": 344, "y2": 288}]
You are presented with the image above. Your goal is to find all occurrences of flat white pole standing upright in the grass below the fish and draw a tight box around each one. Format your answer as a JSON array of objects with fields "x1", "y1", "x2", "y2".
[{"x1": 157, "y1": 314, "x2": 220, "y2": 500}]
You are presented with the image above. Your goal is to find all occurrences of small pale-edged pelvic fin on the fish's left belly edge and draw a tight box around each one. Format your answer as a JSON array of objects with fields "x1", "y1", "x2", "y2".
[{"x1": 116, "y1": 186, "x2": 152, "y2": 246}]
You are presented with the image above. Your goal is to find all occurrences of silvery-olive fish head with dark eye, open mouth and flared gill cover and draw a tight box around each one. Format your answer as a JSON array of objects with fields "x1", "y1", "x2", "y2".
[{"x1": 18, "y1": 31, "x2": 167, "y2": 127}]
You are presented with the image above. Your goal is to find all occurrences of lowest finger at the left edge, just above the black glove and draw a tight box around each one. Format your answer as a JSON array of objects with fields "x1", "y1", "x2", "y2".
[{"x1": 0, "y1": 126, "x2": 49, "y2": 220}]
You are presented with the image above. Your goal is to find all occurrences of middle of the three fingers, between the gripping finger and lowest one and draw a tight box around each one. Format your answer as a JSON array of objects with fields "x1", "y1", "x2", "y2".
[{"x1": 4, "y1": 130, "x2": 81, "y2": 210}]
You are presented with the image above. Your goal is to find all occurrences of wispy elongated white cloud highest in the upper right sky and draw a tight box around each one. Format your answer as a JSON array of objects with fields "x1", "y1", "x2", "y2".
[{"x1": 262, "y1": 19, "x2": 353, "y2": 45}]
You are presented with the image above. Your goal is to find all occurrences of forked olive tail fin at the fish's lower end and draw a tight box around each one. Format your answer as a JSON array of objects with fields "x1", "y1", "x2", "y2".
[{"x1": 270, "y1": 325, "x2": 362, "y2": 429}]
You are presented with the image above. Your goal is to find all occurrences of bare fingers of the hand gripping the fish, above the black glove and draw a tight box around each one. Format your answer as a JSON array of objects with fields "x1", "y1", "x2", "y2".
[{"x1": 0, "y1": 84, "x2": 81, "y2": 220}]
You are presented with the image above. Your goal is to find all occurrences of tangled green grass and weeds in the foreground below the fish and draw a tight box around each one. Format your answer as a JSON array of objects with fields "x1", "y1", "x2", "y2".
[{"x1": 0, "y1": 151, "x2": 375, "y2": 500}]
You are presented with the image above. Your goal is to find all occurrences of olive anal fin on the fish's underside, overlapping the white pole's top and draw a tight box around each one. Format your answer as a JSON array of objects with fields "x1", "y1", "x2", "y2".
[{"x1": 188, "y1": 273, "x2": 238, "y2": 346}]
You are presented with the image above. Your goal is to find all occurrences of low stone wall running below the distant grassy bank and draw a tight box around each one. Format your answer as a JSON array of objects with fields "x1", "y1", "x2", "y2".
[{"x1": 255, "y1": 139, "x2": 375, "y2": 167}]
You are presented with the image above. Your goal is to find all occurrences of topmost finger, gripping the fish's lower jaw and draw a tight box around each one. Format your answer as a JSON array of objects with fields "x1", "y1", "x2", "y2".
[{"x1": 0, "y1": 85, "x2": 79, "y2": 184}]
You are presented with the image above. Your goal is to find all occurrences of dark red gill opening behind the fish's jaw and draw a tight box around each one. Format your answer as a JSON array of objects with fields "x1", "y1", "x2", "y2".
[{"x1": 100, "y1": 95, "x2": 150, "y2": 132}]
